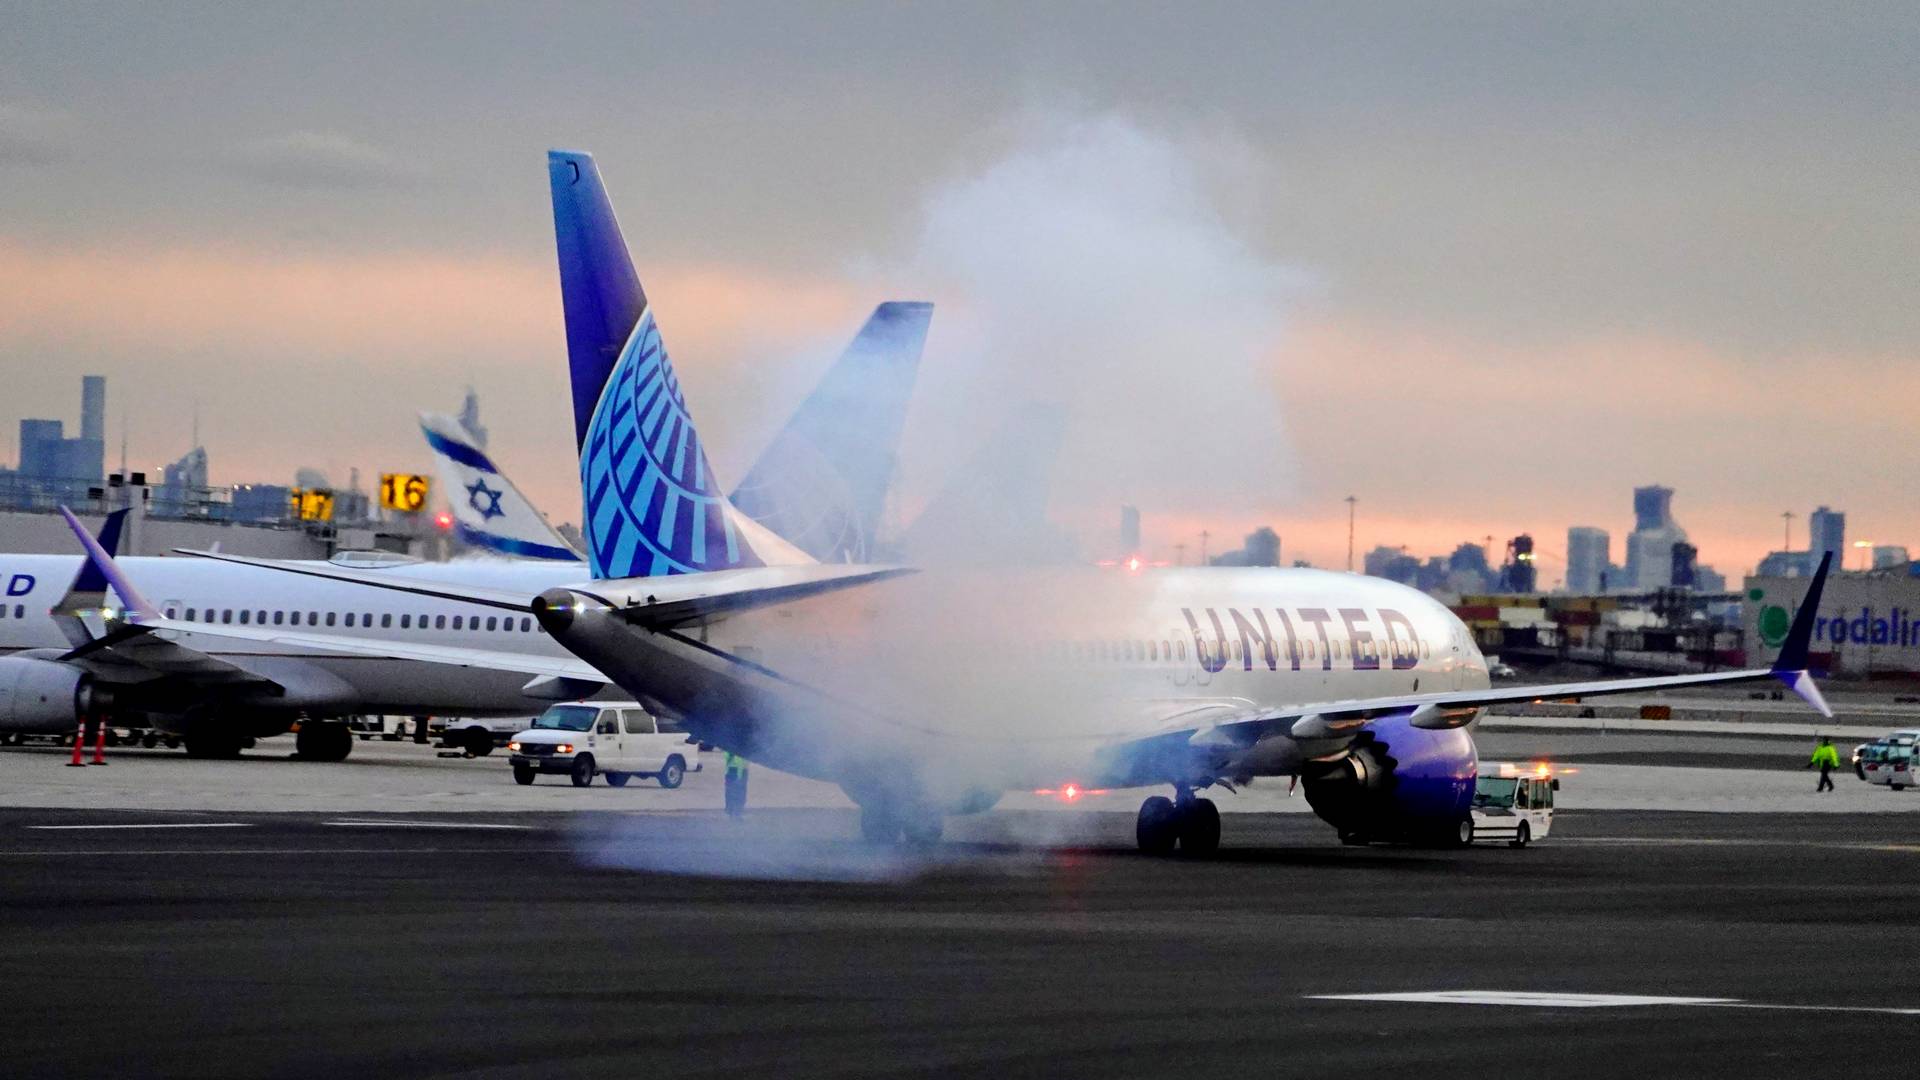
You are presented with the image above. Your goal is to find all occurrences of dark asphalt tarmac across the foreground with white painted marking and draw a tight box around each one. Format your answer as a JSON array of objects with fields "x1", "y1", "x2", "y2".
[{"x1": 0, "y1": 809, "x2": 1920, "y2": 1078}]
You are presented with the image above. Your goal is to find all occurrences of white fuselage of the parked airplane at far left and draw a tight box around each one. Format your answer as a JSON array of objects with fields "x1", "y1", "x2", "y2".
[{"x1": 0, "y1": 555, "x2": 586, "y2": 717}]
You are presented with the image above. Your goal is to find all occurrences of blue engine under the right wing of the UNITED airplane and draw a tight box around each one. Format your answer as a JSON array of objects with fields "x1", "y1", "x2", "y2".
[{"x1": 1300, "y1": 717, "x2": 1480, "y2": 840}]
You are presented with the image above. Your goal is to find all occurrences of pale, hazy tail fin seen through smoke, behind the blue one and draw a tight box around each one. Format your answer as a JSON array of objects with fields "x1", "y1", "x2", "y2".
[{"x1": 733, "y1": 302, "x2": 933, "y2": 563}]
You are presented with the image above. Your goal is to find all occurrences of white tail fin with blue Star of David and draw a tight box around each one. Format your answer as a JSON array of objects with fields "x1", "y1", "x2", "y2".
[{"x1": 420, "y1": 413, "x2": 580, "y2": 563}]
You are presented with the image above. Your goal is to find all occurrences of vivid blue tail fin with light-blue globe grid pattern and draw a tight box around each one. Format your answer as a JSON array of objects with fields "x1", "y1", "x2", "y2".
[{"x1": 547, "y1": 152, "x2": 762, "y2": 578}]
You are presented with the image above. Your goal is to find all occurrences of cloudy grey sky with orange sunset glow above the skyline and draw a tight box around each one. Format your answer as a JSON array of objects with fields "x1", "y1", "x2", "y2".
[{"x1": 0, "y1": 4, "x2": 1920, "y2": 578}]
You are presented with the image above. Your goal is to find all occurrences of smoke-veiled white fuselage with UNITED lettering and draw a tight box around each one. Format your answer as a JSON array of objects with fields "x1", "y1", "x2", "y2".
[{"x1": 563, "y1": 569, "x2": 1488, "y2": 798}]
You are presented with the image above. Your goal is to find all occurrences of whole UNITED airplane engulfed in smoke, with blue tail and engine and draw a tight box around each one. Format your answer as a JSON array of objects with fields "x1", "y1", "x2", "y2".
[{"x1": 168, "y1": 154, "x2": 1830, "y2": 853}]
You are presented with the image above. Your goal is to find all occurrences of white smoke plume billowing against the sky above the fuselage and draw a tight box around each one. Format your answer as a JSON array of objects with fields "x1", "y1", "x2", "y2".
[{"x1": 887, "y1": 115, "x2": 1308, "y2": 553}]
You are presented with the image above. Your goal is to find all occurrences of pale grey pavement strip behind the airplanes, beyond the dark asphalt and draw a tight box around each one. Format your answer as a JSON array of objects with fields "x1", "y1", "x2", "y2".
[{"x1": 0, "y1": 721, "x2": 1920, "y2": 815}]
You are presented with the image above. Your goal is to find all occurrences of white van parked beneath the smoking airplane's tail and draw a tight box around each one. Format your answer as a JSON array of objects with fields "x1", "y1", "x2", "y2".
[{"x1": 507, "y1": 701, "x2": 701, "y2": 788}]
